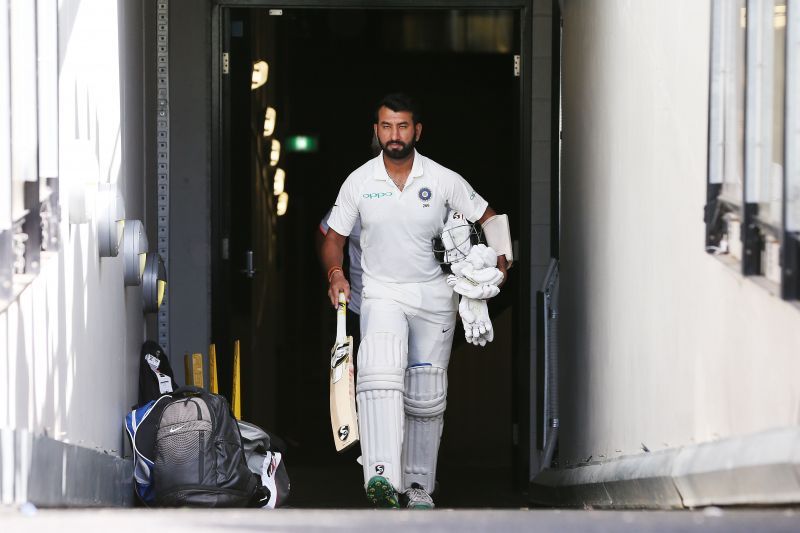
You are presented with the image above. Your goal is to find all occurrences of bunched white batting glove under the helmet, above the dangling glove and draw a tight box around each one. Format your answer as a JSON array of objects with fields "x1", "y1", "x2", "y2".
[{"x1": 447, "y1": 244, "x2": 503, "y2": 300}]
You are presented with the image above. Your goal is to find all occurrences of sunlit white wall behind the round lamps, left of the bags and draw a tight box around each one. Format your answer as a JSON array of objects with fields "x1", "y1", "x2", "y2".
[{"x1": 0, "y1": 0, "x2": 144, "y2": 504}]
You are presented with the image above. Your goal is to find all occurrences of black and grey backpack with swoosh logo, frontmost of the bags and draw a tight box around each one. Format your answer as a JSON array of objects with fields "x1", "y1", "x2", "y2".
[{"x1": 152, "y1": 387, "x2": 265, "y2": 507}]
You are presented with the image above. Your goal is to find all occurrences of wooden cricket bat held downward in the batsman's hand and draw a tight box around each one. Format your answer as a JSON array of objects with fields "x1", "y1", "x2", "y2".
[{"x1": 331, "y1": 292, "x2": 358, "y2": 452}]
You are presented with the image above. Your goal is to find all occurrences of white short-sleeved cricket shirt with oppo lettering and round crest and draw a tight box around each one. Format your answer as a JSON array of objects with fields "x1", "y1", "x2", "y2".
[{"x1": 328, "y1": 150, "x2": 489, "y2": 283}]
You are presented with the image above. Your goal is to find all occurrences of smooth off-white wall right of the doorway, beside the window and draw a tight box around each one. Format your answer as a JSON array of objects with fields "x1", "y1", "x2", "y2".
[{"x1": 559, "y1": 0, "x2": 800, "y2": 464}]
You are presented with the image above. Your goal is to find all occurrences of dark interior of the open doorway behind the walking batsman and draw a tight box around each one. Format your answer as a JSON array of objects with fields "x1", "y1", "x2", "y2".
[{"x1": 211, "y1": 3, "x2": 531, "y2": 507}]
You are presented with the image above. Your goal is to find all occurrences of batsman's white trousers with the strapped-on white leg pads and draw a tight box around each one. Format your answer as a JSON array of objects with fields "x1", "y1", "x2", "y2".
[{"x1": 356, "y1": 275, "x2": 458, "y2": 492}]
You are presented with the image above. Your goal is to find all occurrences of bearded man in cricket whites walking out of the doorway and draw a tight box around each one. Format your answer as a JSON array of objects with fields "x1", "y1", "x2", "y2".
[{"x1": 322, "y1": 94, "x2": 511, "y2": 508}]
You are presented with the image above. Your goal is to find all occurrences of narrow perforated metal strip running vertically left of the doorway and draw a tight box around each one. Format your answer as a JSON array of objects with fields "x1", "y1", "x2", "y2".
[{"x1": 156, "y1": 0, "x2": 169, "y2": 350}]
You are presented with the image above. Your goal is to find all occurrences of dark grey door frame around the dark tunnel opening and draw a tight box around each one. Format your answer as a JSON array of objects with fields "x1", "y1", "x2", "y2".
[{"x1": 210, "y1": 0, "x2": 538, "y2": 491}]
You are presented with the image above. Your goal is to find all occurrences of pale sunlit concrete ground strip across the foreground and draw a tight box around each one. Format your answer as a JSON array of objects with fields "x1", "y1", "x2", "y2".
[{"x1": 0, "y1": 506, "x2": 800, "y2": 533}]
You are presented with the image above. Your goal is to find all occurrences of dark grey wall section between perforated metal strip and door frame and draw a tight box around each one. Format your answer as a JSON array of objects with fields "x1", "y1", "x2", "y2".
[{"x1": 165, "y1": 0, "x2": 212, "y2": 372}]
